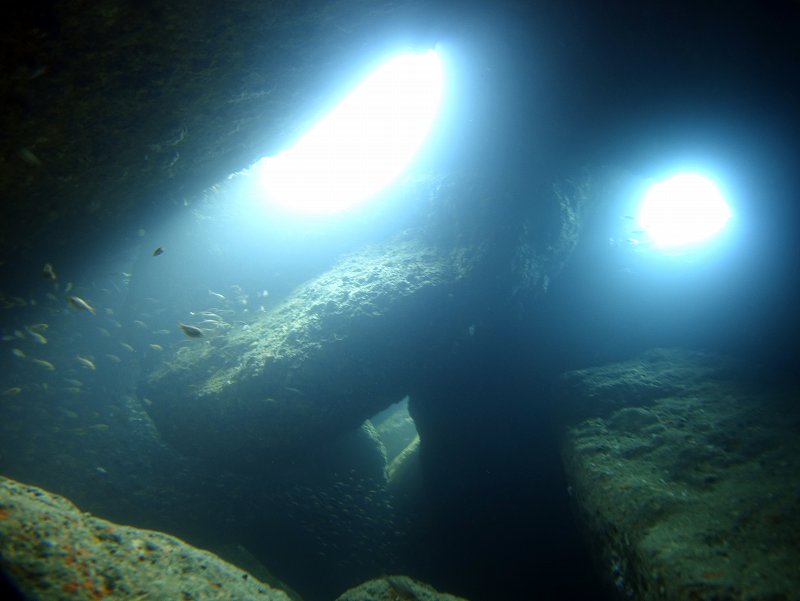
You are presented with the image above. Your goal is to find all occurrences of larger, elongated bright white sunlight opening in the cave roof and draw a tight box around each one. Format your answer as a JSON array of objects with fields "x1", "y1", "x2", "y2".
[{"x1": 254, "y1": 50, "x2": 444, "y2": 215}]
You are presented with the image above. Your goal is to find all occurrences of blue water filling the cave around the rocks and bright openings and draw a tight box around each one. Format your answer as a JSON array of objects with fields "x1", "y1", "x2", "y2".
[{"x1": 0, "y1": 3, "x2": 800, "y2": 601}]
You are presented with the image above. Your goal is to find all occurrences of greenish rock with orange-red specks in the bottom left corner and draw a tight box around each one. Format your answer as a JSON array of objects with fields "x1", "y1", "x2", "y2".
[{"x1": 0, "y1": 478, "x2": 290, "y2": 601}]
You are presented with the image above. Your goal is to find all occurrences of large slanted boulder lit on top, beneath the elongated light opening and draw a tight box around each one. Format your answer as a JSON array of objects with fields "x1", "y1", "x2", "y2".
[{"x1": 144, "y1": 241, "x2": 463, "y2": 462}]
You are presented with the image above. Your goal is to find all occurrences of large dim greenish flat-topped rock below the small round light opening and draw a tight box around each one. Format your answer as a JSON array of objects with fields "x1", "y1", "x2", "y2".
[{"x1": 560, "y1": 350, "x2": 800, "y2": 601}]
